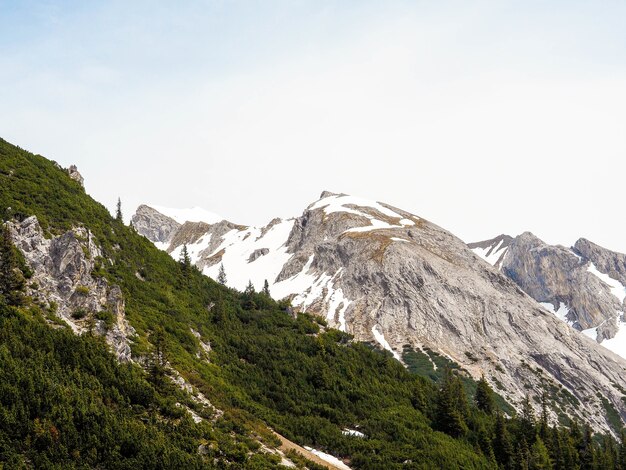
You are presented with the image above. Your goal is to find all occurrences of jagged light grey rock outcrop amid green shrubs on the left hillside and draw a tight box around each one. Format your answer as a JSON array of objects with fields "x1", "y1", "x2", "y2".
[{"x1": 8, "y1": 216, "x2": 135, "y2": 361}]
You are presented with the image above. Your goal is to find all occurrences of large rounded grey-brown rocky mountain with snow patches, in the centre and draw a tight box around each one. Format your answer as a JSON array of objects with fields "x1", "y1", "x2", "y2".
[{"x1": 133, "y1": 192, "x2": 626, "y2": 436}]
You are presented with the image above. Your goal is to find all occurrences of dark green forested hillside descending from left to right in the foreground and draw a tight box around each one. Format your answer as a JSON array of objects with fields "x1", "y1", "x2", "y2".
[{"x1": 0, "y1": 140, "x2": 626, "y2": 470}]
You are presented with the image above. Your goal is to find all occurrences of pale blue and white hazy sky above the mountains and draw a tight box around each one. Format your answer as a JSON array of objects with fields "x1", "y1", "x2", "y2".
[{"x1": 0, "y1": 0, "x2": 626, "y2": 252}]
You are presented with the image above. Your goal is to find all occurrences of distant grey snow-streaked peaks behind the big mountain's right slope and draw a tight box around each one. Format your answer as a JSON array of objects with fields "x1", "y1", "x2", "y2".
[{"x1": 468, "y1": 232, "x2": 626, "y2": 357}]
